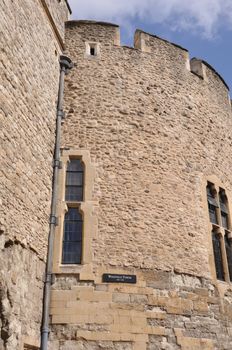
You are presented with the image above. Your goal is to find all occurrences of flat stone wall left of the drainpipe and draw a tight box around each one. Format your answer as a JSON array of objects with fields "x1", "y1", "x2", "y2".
[{"x1": 0, "y1": 0, "x2": 68, "y2": 350}]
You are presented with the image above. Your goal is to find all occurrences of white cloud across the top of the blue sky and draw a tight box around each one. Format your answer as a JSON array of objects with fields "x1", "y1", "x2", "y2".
[{"x1": 69, "y1": 0, "x2": 232, "y2": 38}]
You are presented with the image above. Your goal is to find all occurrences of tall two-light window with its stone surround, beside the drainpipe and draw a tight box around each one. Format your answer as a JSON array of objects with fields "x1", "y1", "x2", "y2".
[{"x1": 53, "y1": 148, "x2": 97, "y2": 272}]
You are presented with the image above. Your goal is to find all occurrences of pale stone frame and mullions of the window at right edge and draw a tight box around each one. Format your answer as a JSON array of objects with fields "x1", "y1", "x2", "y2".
[{"x1": 203, "y1": 175, "x2": 232, "y2": 297}]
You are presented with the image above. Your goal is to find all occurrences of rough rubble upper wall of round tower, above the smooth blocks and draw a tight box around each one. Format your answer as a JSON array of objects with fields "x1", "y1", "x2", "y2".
[{"x1": 63, "y1": 22, "x2": 231, "y2": 277}]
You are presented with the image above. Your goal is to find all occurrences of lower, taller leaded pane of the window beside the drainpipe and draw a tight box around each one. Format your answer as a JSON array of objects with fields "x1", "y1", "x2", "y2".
[{"x1": 62, "y1": 208, "x2": 83, "y2": 264}]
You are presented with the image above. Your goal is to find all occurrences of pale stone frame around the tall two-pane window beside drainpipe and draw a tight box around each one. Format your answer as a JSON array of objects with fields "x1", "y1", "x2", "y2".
[{"x1": 53, "y1": 149, "x2": 97, "y2": 280}]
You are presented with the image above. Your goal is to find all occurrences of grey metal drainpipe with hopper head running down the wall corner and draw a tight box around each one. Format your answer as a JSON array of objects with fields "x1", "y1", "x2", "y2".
[{"x1": 40, "y1": 56, "x2": 73, "y2": 350}]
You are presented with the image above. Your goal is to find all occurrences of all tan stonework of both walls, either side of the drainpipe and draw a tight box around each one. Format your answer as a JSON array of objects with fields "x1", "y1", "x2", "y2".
[{"x1": 0, "y1": 0, "x2": 232, "y2": 350}]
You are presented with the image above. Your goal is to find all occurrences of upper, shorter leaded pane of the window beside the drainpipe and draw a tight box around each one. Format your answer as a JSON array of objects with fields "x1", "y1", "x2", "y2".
[{"x1": 65, "y1": 159, "x2": 84, "y2": 202}]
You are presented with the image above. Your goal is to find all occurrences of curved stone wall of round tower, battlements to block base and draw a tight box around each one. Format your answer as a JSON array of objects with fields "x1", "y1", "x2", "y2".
[{"x1": 50, "y1": 21, "x2": 232, "y2": 350}]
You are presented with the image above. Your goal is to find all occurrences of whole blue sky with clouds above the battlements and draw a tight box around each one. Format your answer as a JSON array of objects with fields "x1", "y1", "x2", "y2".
[{"x1": 69, "y1": 0, "x2": 232, "y2": 95}]
